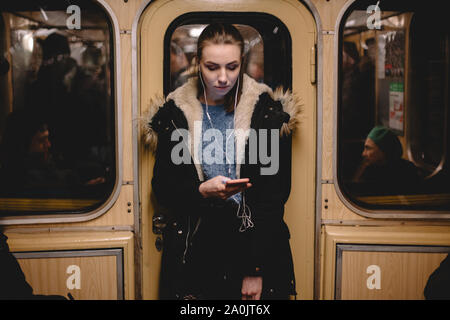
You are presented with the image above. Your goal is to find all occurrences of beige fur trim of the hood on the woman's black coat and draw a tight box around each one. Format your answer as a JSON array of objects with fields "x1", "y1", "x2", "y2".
[{"x1": 143, "y1": 74, "x2": 301, "y2": 154}]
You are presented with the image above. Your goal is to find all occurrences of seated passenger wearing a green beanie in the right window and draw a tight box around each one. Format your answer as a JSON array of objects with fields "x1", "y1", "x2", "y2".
[{"x1": 354, "y1": 126, "x2": 421, "y2": 194}]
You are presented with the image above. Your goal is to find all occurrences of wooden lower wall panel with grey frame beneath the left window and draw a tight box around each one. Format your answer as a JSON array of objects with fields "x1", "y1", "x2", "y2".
[{"x1": 14, "y1": 249, "x2": 123, "y2": 300}]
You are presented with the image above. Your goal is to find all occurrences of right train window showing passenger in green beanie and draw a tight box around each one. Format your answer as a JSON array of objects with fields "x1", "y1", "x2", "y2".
[{"x1": 337, "y1": 0, "x2": 450, "y2": 212}]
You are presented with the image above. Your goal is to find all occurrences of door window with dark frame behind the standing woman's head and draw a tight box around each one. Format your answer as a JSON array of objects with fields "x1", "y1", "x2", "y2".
[{"x1": 164, "y1": 12, "x2": 292, "y2": 94}]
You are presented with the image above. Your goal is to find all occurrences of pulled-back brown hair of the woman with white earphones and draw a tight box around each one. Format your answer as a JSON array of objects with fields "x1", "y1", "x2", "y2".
[{"x1": 197, "y1": 23, "x2": 244, "y2": 112}]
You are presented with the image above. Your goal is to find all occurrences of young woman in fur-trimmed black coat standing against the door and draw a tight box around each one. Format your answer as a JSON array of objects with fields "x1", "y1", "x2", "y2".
[{"x1": 146, "y1": 24, "x2": 299, "y2": 300}]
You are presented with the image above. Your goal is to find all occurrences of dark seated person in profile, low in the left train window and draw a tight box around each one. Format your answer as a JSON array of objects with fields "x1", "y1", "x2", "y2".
[{"x1": 0, "y1": 112, "x2": 104, "y2": 197}]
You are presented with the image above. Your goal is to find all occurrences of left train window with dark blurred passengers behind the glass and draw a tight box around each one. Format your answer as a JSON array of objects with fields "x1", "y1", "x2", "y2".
[{"x1": 0, "y1": 0, "x2": 116, "y2": 216}]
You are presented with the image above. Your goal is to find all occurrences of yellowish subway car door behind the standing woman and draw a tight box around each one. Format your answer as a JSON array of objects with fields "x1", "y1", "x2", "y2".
[{"x1": 134, "y1": 0, "x2": 317, "y2": 299}]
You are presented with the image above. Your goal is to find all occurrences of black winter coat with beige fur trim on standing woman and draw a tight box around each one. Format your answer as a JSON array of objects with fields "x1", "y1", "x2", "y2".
[{"x1": 146, "y1": 76, "x2": 299, "y2": 299}]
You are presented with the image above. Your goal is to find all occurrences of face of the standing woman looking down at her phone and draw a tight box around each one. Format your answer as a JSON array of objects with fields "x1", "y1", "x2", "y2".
[{"x1": 200, "y1": 44, "x2": 241, "y2": 102}]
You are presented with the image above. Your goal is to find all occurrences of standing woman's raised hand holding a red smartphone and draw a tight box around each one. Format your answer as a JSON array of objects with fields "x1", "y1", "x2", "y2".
[{"x1": 198, "y1": 176, "x2": 252, "y2": 200}]
